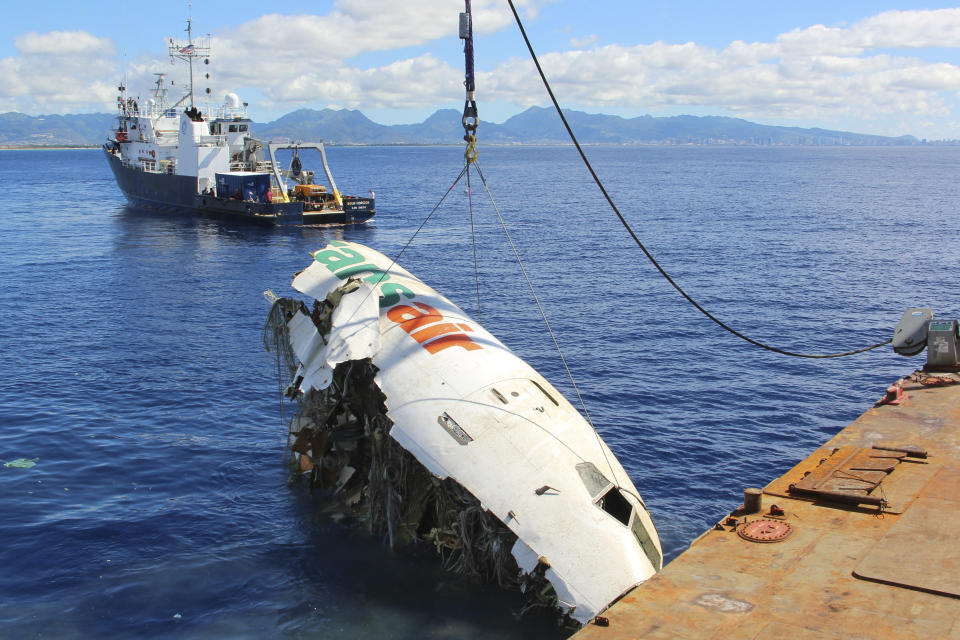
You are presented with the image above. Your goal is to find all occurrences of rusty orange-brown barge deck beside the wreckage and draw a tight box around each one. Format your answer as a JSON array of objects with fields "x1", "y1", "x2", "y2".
[{"x1": 574, "y1": 372, "x2": 960, "y2": 640}]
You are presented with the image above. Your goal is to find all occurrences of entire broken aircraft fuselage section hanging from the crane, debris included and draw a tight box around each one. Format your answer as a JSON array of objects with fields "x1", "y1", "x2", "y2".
[{"x1": 264, "y1": 241, "x2": 662, "y2": 623}]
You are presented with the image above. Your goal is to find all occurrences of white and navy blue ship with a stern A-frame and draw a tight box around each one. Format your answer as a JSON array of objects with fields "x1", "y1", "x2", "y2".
[{"x1": 103, "y1": 20, "x2": 376, "y2": 225}]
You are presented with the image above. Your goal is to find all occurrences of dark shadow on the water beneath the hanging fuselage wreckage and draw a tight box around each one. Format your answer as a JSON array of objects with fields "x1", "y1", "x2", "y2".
[{"x1": 258, "y1": 487, "x2": 570, "y2": 640}]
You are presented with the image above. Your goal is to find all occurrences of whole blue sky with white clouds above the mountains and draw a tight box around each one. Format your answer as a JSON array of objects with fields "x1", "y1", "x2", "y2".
[{"x1": 0, "y1": 0, "x2": 960, "y2": 139}]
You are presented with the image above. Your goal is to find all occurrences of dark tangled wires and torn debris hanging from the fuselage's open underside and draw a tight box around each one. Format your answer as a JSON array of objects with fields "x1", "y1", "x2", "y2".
[{"x1": 264, "y1": 296, "x2": 528, "y2": 592}]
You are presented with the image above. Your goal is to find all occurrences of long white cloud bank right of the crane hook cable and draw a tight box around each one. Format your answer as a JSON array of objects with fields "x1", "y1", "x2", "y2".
[{"x1": 482, "y1": 9, "x2": 960, "y2": 132}]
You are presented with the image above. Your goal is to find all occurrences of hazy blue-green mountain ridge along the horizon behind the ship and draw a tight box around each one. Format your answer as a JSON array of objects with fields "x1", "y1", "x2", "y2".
[{"x1": 0, "y1": 107, "x2": 922, "y2": 148}]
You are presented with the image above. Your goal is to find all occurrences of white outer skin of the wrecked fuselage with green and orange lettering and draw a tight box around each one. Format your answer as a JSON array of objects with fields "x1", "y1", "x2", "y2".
[{"x1": 270, "y1": 241, "x2": 662, "y2": 623}]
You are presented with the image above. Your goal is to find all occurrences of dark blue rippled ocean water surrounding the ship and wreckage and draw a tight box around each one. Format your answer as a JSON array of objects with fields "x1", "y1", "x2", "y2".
[{"x1": 0, "y1": 142, "x2": 960, "y2": 639}]
